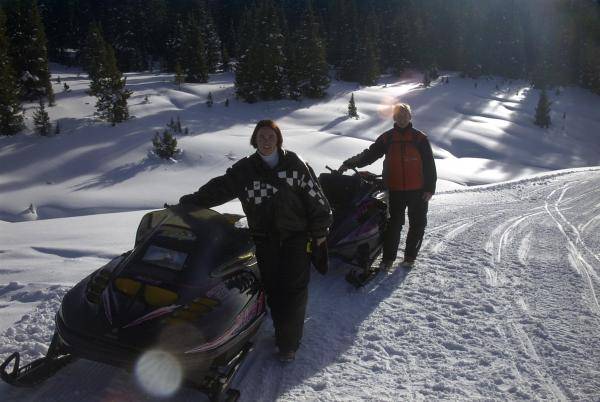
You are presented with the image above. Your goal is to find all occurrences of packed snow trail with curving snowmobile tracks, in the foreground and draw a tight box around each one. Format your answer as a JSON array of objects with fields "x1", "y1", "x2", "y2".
[{"x1": 0, "y1": 169, "x2": 600, "y2": 401}]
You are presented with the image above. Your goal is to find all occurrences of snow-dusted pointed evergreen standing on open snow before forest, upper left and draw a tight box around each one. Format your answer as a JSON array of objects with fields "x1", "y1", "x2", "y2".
[{"x1": 90, "y1": 44, "x2": 132, "y2": 126}]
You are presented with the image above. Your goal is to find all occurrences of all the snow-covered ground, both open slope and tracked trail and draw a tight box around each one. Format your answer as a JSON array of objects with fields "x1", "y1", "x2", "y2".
[{"x1": 0, "y1": 70, "x2": 600, "y2": 401}]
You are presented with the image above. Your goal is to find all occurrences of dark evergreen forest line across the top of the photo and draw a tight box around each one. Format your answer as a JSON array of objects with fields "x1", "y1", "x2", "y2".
[{"x1": 0, "y1": 0, "x2": 600, "y2": 133}]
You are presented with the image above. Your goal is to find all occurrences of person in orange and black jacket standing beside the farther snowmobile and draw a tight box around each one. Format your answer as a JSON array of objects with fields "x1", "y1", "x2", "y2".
[{"x1": 339, "y1": 103, "x2": 437, "y2": 270}]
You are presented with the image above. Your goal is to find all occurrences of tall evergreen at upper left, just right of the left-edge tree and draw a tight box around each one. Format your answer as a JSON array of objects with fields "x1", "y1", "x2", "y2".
[{"x1": 7, "y1": 0, "x2": 54, "y2": 106}]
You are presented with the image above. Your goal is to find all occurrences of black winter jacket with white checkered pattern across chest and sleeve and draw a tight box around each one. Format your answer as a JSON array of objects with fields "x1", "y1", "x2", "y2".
[{"x1": 179, "y1": 149, "x2": 332, "y2": 238}]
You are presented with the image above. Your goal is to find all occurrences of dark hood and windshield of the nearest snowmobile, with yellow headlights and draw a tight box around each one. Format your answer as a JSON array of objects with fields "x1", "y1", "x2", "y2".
[{"x1": 60, "y1": 208, "x2": 260, "y2": 354}]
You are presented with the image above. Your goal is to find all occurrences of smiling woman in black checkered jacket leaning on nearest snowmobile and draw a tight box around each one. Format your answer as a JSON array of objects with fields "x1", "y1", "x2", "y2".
[{"x1": 179, "y1": 120, "x2": 332, "y2": 361}]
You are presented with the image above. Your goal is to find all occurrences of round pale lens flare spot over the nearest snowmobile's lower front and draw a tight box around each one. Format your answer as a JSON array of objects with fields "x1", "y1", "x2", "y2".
[{"x1": 135, "y1": 350, "x2": 183, "y2": 398}]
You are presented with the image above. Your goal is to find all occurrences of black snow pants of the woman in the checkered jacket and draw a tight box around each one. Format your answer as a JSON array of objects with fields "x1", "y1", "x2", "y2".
[{"x1": 255, "y1": 233, "x2": 310, "y2": 352}]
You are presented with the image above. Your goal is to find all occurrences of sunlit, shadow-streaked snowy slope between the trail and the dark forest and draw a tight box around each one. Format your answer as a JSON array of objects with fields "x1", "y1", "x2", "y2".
[{"x1": 0, "y1": 67, "x2": 600, "y2": 222}]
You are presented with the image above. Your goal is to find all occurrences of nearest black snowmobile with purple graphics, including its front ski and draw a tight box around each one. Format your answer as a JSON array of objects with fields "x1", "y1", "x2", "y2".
[{"x1": 0, "y1": 205, "x2": 265, "y2": 401}]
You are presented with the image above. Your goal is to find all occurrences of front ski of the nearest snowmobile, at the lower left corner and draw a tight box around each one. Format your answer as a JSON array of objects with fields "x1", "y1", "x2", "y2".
[{"x1": 0, "y1": 352, "x2": 73, "y2": 387}]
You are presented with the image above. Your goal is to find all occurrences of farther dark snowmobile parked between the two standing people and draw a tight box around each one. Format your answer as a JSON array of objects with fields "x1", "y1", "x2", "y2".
[{"x1": 319, "y1": 166, "x2": 388, "y2": 288}]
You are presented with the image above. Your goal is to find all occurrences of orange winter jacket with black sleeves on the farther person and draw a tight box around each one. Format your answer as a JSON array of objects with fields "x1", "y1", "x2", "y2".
[{"x1": 344, "y1": 124, "x2": 437, "y2": 194}]
